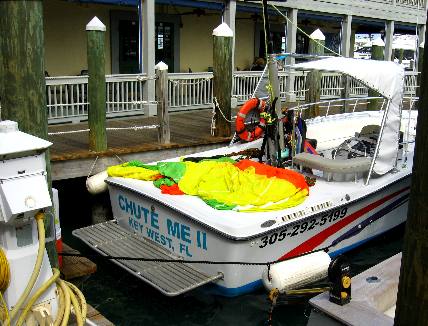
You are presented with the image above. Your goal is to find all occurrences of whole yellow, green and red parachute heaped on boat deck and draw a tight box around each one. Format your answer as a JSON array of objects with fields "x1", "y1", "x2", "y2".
[{"x1": 107, "y1": 159, "x2": 309, "y2": 212}]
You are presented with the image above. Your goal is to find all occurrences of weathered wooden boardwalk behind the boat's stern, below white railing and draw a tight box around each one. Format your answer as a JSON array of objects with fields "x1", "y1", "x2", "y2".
[{"x1": 48, "y1": 109, "x2": 234, "y2": 180}]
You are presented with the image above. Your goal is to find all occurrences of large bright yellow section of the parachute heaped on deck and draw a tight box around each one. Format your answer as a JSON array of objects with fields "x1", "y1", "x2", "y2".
[{"x1": 178, "y1": 161, "x2": 308, "y2": 211}]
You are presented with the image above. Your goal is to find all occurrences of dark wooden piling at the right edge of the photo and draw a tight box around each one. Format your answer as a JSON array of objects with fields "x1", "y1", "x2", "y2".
[{"x1": 394, "y1": 38, "x2": 428, "y2": 326}]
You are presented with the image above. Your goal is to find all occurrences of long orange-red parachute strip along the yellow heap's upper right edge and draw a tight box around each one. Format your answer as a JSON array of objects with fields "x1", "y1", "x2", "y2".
[{"x1": 235, "y1": 160, "x2": 309, "y2": 193}]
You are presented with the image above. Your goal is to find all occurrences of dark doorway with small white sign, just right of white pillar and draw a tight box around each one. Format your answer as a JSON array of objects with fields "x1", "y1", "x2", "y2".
[{"x1": 155, "y1": 22, "x2": 174, "y2": 72}]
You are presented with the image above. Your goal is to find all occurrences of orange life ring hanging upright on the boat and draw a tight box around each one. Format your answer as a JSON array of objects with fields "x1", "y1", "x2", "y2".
[{"x1": 235, "y1": 98, "x2": 266, "y2": 141}]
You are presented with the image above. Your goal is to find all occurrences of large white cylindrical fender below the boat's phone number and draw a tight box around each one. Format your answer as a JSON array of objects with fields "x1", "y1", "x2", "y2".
[{"x1": 262, "y1": 251, "x2": 331, "y2": 292}]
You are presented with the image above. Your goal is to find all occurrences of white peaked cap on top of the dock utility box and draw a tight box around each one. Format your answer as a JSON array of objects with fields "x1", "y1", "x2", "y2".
[{"x1": 0, "y1": 120, "x2": 52, "y2": 159}]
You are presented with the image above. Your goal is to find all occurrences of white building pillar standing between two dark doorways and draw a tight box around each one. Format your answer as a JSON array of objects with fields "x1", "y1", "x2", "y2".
[{"x1": 140, "y1": 0, "x2": 157, "y2": 116}]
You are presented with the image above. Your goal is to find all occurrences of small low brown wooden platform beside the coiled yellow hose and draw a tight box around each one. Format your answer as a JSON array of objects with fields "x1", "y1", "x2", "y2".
[{"x1": 60, "y1": 243, "x2": 97, "y2": 280}]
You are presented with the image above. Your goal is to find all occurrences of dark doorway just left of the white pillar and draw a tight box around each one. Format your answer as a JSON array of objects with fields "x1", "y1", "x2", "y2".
[{"x1": 119, "y1": 20, "x2": 139, "y2": 74}]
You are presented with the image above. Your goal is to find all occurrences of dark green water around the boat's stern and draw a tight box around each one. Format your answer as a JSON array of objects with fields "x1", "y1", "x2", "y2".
[{"x1": 54, "y1": 179, "x2": 403, "y2": 326}]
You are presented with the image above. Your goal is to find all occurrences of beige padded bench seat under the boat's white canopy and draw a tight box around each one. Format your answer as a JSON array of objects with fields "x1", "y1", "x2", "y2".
[{"x1": 293, "y1": 152, "x2": 372, "y2": 181}]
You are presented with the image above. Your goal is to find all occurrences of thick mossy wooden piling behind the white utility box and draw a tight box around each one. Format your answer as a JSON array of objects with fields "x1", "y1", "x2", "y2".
[{"x1": 0, "y1": 0, "x2": 58, "y2": 267}]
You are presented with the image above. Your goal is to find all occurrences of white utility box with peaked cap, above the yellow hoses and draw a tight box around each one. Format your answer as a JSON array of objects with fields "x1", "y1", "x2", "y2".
[{"x1": 0, "y1": 121, "x2": 52, "y2": 223}]
